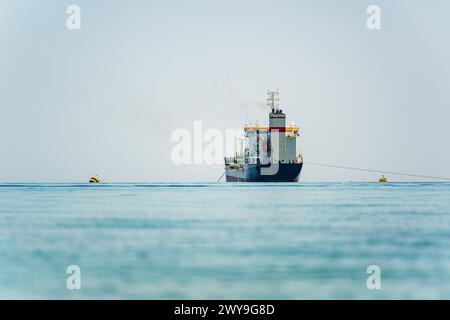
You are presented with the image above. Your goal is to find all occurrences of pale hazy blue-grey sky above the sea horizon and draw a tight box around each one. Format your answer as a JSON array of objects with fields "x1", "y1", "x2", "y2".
[{"x1": 0, "y1": 0, "x2": 450, "y2": 182}]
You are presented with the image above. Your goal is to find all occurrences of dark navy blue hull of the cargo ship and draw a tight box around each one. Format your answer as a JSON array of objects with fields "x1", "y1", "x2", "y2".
[{"x1": 225, "y1": 163, "x2": 303, "y2": 182}]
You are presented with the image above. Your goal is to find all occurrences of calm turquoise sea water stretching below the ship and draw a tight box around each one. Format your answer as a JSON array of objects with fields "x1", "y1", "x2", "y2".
[{"x1": 0, "y1": 183, "x2": 450, "y2": 299}]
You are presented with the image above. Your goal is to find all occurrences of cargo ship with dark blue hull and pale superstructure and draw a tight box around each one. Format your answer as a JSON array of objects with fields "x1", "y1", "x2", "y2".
[{"x1": 225, "y1": 90, "x2": 303, "y2": 182}]
